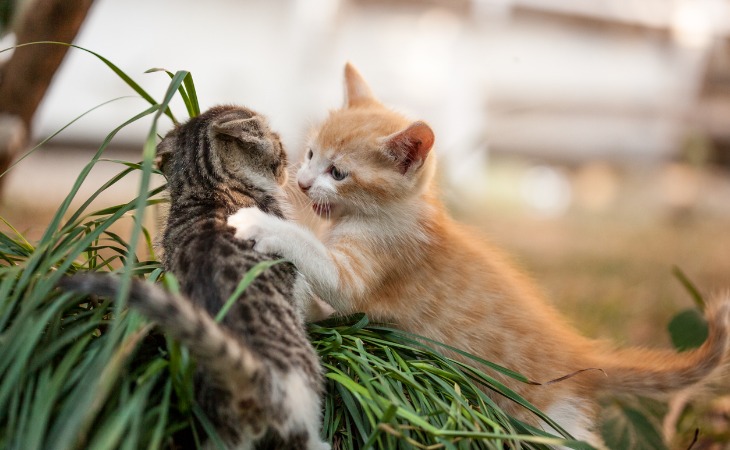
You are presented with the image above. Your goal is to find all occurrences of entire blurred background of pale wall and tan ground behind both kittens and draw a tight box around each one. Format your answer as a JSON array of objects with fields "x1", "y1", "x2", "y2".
[{"x1": 0, "y1": 0, "x2": 730, "y2": 376}]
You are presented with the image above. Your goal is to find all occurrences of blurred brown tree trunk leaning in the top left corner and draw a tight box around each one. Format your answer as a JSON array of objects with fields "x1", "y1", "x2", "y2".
[{"x1": 0, "y1": 0, "x2": 93, "y2": 194}]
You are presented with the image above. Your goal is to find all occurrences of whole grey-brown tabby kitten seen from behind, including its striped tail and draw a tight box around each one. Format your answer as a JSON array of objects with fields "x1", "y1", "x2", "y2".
[{"x1": 64, "y1": 106, "x2": 330, "y2": 450}]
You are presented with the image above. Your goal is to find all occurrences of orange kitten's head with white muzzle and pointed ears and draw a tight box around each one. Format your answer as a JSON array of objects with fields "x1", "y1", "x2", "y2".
[{"x1": 297, "y1": 64, "x2": 435, "y2": 219}]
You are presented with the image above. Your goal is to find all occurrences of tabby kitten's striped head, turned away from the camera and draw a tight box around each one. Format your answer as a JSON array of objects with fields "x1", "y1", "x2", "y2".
[{"x1": 157, "y1": 106, "x2": 287, "y2": 198}]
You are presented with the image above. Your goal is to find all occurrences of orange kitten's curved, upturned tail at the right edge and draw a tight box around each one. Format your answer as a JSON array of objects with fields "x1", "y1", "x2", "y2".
[{"x1": 598, "y1": 296, "x2": 730, "y2": 395}]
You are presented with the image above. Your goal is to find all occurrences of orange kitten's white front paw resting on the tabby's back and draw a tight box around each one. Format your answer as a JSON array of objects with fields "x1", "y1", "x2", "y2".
[{"x1": 228, "y1": 207, "x2": 282, "y2": 253}]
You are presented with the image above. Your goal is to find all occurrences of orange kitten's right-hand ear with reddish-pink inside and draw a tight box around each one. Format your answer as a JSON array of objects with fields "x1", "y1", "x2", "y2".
[{"x1": 385, "y1": 121, "x2": 435, "y2": 174}]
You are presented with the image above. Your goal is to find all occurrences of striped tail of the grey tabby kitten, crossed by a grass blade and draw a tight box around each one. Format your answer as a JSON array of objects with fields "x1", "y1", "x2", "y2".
[{"x1": 58, "y1": 274, "x2": 265, "y2": 392}]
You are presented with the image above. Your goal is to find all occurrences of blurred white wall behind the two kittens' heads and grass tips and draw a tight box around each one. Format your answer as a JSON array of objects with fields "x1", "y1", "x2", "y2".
[{"x1": 27, "y1": 0, "x2": 717, "y2": 169}]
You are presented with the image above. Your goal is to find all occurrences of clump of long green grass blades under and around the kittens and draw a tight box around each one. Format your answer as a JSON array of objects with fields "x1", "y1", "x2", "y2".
[{"x1": 0, "y1": 44, "x2": 589, "y2": 450}]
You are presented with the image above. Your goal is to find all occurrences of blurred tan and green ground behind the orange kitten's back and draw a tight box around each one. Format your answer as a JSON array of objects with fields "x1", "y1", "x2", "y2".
[{"x1": 478, "y1": 213, "x2": 730, "y2": 346}]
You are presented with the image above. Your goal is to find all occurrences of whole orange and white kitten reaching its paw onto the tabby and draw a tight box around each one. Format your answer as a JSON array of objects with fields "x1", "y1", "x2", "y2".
[{"x1": 229, "y1": 64, "x2": 730, "y2": 445}]
